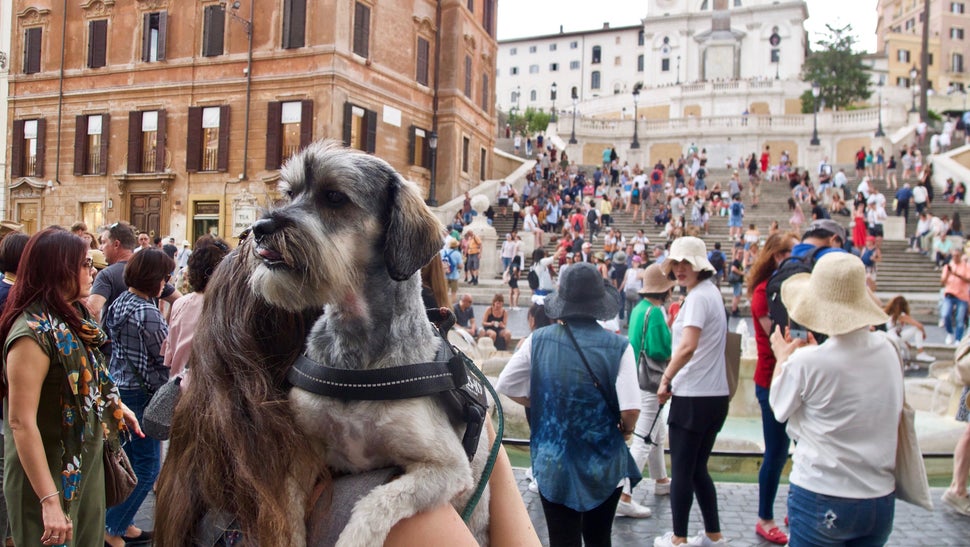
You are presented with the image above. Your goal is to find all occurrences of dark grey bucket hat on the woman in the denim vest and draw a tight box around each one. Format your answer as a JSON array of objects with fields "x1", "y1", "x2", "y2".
[{"x1": 545, "y1": 262, "x2": 623, "y2": 321}]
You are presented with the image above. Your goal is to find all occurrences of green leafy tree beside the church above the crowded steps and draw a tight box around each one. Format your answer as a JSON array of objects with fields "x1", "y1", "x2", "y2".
[{"x1": 802, "y1": 25, "x2": 872, "y2": 113}]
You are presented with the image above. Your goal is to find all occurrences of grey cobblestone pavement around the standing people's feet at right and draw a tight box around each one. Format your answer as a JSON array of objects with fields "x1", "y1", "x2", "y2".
[{"x1": 515, "y1": 469, "x2": 970, "y2": 547}]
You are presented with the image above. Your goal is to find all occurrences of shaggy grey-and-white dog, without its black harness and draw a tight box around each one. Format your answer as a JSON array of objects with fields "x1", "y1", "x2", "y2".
[{"x1": 249, "y1": 142, "x2": 488, "y2": 547}]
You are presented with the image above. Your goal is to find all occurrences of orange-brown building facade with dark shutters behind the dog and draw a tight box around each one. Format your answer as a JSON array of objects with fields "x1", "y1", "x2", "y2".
[{"x1": 7, "y1": 0, "x2": 497, "y2": 241}]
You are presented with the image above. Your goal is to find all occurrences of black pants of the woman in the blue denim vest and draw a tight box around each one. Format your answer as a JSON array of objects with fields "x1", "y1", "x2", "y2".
[{"x1": 539, "y1": 487, "x2": 623, "y2": 547}]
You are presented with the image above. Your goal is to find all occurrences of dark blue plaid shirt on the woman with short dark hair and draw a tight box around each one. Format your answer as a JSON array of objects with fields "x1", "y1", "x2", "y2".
[{"x1": 105, "y1": 291, "x2": 169, "y2": 393}]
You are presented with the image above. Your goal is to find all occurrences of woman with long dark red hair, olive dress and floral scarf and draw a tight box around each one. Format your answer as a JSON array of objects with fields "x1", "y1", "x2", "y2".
[{"x1": 0, "y1": 227, "x2": 142, "y2": 546}]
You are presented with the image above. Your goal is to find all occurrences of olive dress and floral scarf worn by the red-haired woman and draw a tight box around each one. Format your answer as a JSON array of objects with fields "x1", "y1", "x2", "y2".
[{"x1": 3, "y1": 304, "x2": 124, "y2": 546}]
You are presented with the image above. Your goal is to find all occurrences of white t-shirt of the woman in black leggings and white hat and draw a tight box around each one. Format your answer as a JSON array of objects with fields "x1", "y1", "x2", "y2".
[{"x1": 670, "y1": 280, "x2": 728, "y2": 397}]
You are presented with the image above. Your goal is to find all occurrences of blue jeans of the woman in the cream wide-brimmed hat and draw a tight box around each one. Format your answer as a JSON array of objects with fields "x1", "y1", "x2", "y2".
[{"x1": 788, "y1": 484, "x2": 896, "y2": 547}]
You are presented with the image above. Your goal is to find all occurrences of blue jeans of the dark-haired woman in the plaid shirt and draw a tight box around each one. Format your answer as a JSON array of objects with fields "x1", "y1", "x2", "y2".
[{"x1": 105, "y1": 388, "x2": 161, "y2": 536}]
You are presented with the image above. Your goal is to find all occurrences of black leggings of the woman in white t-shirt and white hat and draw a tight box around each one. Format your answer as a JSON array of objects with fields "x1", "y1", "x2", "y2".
[{"x1": 667, "y1": 397, "x2": 728, "y2": 537}]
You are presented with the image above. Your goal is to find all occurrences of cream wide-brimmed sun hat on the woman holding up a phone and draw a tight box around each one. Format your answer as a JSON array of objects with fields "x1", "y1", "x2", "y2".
[{"x1": 781, "y1": 253, "x2": 889, "y2": 336}]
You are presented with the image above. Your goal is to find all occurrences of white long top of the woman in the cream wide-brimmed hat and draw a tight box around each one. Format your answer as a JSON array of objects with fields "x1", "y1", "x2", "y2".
[{"x1": 769, "y1": 328, "x2": 903, "y2": 499}]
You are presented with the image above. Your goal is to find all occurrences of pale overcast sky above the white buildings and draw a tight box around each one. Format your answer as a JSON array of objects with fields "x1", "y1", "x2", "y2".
[{"x1": 498, "y1": 0, "x2": 878, "y2": 52}]
